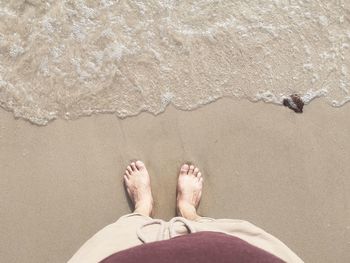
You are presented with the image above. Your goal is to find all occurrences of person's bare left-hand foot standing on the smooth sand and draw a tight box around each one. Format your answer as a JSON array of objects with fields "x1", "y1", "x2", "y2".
[{"x1": 124, "y1": 161, "x2": 153, "y2": 216}]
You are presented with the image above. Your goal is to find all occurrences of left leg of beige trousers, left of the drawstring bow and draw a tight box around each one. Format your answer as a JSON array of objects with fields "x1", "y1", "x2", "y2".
[{"x1": 68, "y1": 213, "x2": 152, "y2": 263}]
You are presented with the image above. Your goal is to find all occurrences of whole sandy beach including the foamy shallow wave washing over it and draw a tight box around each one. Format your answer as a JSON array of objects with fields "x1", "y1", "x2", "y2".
[{"x1": 0, "y1": 0, "x2": 350, "y2": 263}]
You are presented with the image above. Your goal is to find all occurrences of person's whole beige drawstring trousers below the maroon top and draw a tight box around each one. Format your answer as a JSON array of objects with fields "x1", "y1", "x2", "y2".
[{"x1": 68, "y1": 213, "x2": 303, "y2": 263}]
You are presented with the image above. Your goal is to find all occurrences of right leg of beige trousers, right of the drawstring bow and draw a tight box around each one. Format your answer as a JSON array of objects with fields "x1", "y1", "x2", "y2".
[{"x1": 190, "y1": 217, "x2": 303, "y2": 263}]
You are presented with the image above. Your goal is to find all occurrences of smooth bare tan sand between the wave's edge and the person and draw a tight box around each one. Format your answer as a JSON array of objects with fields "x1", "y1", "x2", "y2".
[{"x1": 0, "y1": 99, "x2": 350, "y2": 263}]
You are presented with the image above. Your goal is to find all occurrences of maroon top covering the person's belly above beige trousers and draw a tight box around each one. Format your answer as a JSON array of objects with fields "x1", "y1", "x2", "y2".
[{"x1": 101, "y1": 232, "x2": 284, "y2": 263}]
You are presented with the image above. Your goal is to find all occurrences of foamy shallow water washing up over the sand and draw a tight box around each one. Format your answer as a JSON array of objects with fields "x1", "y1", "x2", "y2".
[{"x1": 0, "y1": 0, "x2": 350, "y2": 125}]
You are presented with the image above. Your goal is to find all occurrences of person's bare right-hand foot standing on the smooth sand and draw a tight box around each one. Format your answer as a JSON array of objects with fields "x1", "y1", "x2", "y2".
[{"x1": 176, "y1": 164, "x2": 203, "y2": 220}]
